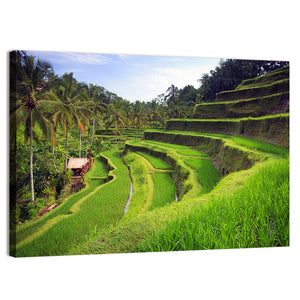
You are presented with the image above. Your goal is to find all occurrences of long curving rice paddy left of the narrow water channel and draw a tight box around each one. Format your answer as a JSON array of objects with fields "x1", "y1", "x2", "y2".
[{"x1": 16, "y1": 151, "x2": 130, "y2": 257}]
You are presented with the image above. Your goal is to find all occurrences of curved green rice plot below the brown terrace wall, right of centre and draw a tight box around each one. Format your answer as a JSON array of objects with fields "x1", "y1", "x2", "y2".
[{"x1": 184, "y1": 158, "x2": 220, "y2": 196}]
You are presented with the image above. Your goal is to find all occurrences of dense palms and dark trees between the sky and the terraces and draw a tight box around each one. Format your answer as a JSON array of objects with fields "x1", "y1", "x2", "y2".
[{"x1": 10, "y1": 51, "x2": 288, "y2": 227}]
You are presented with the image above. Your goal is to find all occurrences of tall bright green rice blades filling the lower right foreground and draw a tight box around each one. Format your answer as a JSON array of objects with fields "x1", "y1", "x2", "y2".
[{"x1": 138, "y1": 159, "x2": 289, "y2": 252}]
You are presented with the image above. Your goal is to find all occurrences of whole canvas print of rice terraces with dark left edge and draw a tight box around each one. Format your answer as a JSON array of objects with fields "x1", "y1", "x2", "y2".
[{"x1": 9, "y1": 50, "x2": 289, "y2": 257}]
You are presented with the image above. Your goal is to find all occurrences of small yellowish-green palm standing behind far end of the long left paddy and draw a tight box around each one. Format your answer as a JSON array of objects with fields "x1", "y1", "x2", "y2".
[{"x1": 104, "y1": 98, "x2": 127, "y2": 150}]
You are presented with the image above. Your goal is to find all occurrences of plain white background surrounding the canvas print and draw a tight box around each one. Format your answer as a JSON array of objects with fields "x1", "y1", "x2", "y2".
[{"x1": 0, "y1": 0, "x2": 300, "y2": 300}]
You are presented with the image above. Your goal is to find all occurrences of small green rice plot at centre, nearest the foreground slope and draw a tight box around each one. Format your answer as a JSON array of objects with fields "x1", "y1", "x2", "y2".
[{"x1": 149, "y1": 173, "x2": 176, "y2": 210}]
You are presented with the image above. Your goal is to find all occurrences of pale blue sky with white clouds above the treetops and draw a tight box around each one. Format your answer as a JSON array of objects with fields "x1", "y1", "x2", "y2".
[{"x1": 26, "y1": 51, "x2": 220, "y2": 102}]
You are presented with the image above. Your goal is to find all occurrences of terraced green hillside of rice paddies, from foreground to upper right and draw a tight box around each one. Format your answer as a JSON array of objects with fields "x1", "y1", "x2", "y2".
[{"x1": 13, "y1": 68, "x2": 289, "y2": 256}]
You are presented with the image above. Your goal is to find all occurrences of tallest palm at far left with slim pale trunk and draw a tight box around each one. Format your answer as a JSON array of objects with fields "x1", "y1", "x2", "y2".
[{"x1": 10, "y1": 55, "x2": 55, "y2": 204}]
